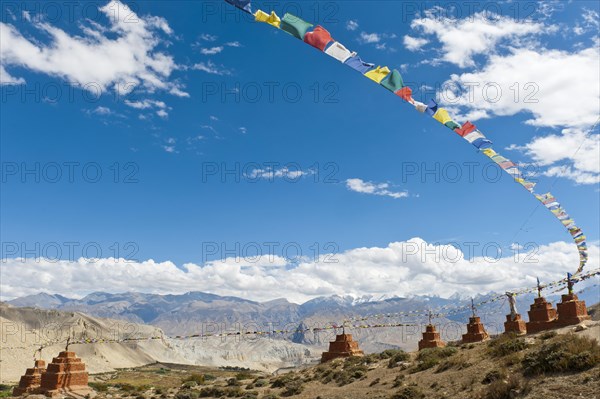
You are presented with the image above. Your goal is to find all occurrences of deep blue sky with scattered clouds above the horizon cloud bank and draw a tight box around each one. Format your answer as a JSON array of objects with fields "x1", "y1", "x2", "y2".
[{"x1": 0, "y1": 1, "x2": 600, "y2": 299}]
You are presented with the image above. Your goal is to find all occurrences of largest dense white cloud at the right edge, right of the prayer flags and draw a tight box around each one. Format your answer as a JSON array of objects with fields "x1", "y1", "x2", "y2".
[{"x1": 440, "y1": 47, "x2": 600, "y2": 128}]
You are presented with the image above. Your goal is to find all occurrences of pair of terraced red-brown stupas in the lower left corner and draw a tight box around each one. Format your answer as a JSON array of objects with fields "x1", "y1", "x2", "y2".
[{"x1": 13, "y1": 342, "x2": 91, "y2": 397}]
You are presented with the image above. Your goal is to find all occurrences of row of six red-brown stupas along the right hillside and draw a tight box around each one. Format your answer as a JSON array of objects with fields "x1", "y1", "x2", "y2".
[{"x1": 321, "y1": 279, "x2": 591, "y2": 363}]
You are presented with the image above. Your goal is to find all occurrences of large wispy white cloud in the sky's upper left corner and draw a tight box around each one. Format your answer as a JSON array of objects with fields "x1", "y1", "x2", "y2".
[{"x1": 0, "y1": 0, "x2": 176, "y2": 97}]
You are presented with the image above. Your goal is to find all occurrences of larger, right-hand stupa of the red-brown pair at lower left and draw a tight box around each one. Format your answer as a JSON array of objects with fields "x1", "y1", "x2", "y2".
[{"x1": 40, "y1": 346, "x2": 91, "y2": 397}]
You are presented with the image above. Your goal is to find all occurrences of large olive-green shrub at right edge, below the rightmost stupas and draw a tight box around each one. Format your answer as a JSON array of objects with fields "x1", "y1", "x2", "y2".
[{"x1": 521, "y1": 334, "x2": 600, "y2": 376}]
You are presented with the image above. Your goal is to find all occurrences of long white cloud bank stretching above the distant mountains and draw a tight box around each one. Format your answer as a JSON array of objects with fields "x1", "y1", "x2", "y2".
[{"x1": 0, "y1": 238, "x2": 600, "y2": 302}]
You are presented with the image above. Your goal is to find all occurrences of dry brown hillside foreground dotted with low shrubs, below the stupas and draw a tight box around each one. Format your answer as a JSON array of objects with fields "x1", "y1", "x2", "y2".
[{"x1": 5, "y1": 321, "x2": 600, "y2": 399}]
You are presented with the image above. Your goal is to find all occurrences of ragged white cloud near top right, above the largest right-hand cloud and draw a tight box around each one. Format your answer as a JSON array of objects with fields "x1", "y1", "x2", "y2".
[{"x1": 412, "y1": 9, "x2": 555, "y2": 68}]
